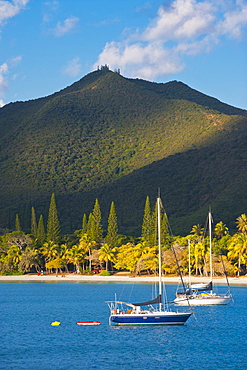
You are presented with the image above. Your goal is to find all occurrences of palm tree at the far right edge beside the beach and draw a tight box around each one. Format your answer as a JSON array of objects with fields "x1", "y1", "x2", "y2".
[{"x1": 228, "y1": 233, "x2": 247, "y2": 276}]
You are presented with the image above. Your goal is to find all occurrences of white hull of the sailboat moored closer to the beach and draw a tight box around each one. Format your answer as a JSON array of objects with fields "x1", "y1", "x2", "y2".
[{"x1": 174, "y1": 294, "x2": 232, "y2": 306}]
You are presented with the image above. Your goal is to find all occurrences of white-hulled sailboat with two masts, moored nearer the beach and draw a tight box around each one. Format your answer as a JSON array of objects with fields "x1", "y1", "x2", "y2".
[{"x1": 174, "y1": 211, "x2": 232, "y2": 306}]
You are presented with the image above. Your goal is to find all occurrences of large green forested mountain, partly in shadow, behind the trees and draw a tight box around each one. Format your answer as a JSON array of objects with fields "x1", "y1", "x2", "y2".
[{"x1": 0, "y1": 67, "x2": 247, "y2": 235}]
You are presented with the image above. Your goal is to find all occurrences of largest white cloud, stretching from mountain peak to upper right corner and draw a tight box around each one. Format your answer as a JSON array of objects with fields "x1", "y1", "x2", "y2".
[{"x1": 94, "y1": 0, "x2": 247, "y2": 79}]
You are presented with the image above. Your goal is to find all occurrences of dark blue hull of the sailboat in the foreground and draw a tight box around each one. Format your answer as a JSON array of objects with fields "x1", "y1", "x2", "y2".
[{"x1": 110, "y1": 313, "x2": 191, "y2": 325}]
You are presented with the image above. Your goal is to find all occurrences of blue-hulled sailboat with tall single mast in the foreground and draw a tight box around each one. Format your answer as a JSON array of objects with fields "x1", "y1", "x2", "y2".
[{"x1": 106, "y1": 197, "x2": 192, "y2": 325}]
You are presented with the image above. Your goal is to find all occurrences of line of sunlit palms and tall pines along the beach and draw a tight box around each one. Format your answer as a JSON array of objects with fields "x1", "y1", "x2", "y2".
[{"x1": 0, "y1": 193, "x2": 247, "y2": 276}]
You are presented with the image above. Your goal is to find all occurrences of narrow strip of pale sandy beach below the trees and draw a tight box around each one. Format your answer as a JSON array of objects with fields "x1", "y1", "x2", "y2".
[{"x1": 0, "y1": 274, "x2": 247, "y2": 286}]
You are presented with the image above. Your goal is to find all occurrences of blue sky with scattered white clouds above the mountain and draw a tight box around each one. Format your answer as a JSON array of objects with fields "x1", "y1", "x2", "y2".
[{"x1": 0, "y1": 0, "x2": 247, "y2": 109}]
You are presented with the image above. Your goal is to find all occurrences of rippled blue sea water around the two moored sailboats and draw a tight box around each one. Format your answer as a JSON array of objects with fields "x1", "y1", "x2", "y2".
[{"x1": 0, "y1": 283, "x2": 247, "y2": 370}]
